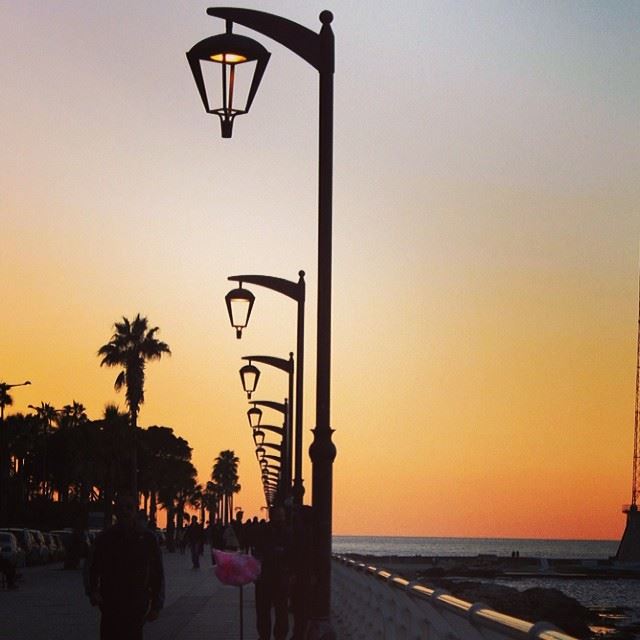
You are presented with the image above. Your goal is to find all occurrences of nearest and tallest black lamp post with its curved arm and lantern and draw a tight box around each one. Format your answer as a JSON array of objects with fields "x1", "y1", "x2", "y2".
[{"x1": 187, "y1": 7, "x2": 336, "y2": 638}]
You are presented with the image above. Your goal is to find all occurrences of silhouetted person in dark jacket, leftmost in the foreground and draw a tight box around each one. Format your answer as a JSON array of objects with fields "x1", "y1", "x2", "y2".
[{"x1": 88, "y1": 494, "x2": 164, "y2": 640}]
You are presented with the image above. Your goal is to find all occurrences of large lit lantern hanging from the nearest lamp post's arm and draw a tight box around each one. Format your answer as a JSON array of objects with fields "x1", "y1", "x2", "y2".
[{"x1": 187, "y1": 20, "x2": 271, "y2": 138}]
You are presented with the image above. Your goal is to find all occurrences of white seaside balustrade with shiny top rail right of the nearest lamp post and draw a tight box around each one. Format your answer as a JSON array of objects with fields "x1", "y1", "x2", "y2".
[{"x1": 332, "y1": 556, "x2": 574, "y2": 640}]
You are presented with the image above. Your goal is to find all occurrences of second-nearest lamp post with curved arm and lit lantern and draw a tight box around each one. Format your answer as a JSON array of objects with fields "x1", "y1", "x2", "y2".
[{"x1": 225, "y1": 271, "x2": 306, "y2": 505}]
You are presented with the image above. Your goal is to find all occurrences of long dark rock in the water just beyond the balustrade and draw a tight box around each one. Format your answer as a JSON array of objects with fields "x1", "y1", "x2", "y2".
[{"x1": 430, "y1": 580, "x2": 597, "y2": 638}]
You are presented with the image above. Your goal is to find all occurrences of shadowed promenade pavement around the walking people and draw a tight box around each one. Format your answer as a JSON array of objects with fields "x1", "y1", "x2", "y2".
[{"x1": 0, "y1": 547, "x2": 258, "y2": 640}]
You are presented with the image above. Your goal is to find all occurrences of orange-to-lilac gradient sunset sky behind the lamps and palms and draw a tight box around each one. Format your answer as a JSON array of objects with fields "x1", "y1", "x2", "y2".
[{"x1": 0, "y1": 0, "x2": 640, "y2": 538}]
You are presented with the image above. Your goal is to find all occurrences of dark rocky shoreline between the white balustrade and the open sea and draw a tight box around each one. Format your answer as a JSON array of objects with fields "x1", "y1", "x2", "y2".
[{"x1": 347, "y1": 554, "x2": 640, "y2": 640}]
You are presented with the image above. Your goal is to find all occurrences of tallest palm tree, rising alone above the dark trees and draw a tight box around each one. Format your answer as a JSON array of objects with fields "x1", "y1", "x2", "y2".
[{"x1": 98, "y1": 314, "x2": 171, "y2": 495}]
